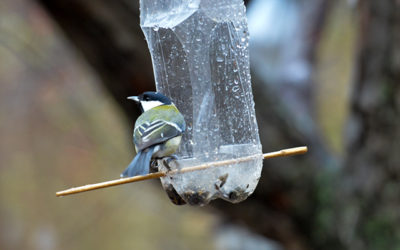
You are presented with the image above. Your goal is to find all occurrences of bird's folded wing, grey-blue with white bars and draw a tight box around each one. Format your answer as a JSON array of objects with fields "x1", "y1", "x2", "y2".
[{"x1": 133, "y1": 119, "x2": 183, "y2": 150}]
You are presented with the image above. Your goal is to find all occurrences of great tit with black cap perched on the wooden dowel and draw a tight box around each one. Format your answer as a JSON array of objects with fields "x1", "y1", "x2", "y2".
[{"x1": 121, "y1": 92, "x2": 186, "y2": 177}]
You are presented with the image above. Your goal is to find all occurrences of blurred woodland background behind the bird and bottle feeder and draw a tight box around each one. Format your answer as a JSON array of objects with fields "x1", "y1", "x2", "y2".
[{"x1": 0, "y1": 0, "x2": 400, "y2": 250}]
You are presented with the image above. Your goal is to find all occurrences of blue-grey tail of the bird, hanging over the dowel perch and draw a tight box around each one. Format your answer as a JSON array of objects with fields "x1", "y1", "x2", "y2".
[{"x1": 121, "y1": 146, "x2": 155, "y2": 177}]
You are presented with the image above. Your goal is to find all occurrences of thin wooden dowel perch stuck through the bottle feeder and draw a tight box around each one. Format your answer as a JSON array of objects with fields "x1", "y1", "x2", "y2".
[{"x1": 56, "y1": 147, "x2": 308, "y2": 196}]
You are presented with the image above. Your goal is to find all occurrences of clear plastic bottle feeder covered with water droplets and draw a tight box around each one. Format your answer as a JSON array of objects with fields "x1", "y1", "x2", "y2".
[{"x1": 140, "y1": 0, "x2": 262, "y2": 205}]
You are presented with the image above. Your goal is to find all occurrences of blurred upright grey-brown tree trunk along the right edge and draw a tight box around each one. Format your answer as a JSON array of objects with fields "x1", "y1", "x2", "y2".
[{"x1": 337, "y1": 0, "x2": 400, "y2": 249}]
